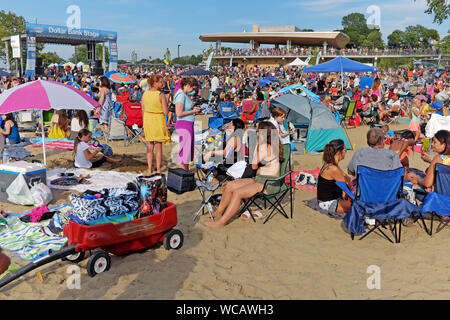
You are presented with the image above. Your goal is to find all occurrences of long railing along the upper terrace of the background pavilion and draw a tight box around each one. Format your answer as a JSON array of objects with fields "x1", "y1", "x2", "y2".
[{"x1": 203, "y1": 48, "x2": 440, "y2": 58}]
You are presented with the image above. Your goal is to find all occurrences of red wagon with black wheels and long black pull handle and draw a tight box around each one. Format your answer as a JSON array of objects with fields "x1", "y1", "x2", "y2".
[{"x1": 0, "y1": 203, "x2": 184, "y2": 288}]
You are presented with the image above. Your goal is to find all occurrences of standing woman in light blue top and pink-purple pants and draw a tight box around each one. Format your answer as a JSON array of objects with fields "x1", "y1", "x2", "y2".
[{"x1": 174, "y1": 77, "x2": 201, "y2": 171}]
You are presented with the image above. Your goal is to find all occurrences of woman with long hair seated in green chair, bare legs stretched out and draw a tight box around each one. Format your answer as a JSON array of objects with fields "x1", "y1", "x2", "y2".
[{"x1": 205, "y1": 122, "x2": 284, "y2": 228}]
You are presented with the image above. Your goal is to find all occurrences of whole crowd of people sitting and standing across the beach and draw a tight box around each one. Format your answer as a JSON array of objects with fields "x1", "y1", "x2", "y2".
[{"x1": 0, "y1": 59, "x2": 450, "y2": 227}]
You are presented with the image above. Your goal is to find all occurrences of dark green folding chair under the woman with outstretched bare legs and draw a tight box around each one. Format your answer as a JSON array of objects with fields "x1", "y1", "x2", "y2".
[{"x1": 239, "y1": 144, "x2": 294, "y2": 224}]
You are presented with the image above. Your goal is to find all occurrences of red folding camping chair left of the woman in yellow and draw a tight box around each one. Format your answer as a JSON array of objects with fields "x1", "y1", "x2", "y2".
[{"x1": 121, "y1": 102, "x2": 145, "y2": 147}]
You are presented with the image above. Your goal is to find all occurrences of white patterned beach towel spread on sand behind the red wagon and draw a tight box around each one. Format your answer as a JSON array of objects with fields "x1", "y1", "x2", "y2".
[{"x1": 47, "y1": 168, "x2": 138, "y2": 193}]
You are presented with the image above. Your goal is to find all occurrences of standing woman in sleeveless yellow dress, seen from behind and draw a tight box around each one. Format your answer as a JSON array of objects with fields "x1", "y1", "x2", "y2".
[{"x1": 142, "y1": 75, "x2": 170, "y2": 174}]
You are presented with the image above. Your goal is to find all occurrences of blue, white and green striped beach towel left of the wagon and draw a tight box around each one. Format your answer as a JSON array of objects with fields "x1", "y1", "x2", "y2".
[{"x1": 0, "y1": 205, "x2": 71, "y2": 262}]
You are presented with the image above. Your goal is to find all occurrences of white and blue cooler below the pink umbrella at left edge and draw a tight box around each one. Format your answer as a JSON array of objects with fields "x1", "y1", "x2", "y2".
[{"x1": 0, "y1": 161, "x2": 47, "y2": 202}]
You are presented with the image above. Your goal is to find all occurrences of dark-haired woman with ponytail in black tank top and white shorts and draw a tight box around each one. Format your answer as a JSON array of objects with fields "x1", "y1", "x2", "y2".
[{"x1": 317, "y1": 140, "x2": 351, "y2": 213}]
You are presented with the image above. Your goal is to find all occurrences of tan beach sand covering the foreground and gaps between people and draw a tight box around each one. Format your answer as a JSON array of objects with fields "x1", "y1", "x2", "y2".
[{"x1": 0, "y1": 118, "x2": 450, "y2": 300}]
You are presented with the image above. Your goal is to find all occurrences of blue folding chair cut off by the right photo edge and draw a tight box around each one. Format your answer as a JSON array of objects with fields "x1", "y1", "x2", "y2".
[{"x1": 420, "y1": 164, "x2": 450, "y2": 236}]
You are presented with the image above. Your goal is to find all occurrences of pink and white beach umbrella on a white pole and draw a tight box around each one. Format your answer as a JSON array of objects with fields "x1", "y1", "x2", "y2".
[{"x1": 0, "y1": 80, "x2": 101, "y2": 165}]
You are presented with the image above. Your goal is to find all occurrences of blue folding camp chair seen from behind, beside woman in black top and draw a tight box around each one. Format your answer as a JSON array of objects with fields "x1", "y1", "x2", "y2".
[{"x1": 342, "y1": 166, "x2": 407, "y2": 243}]
